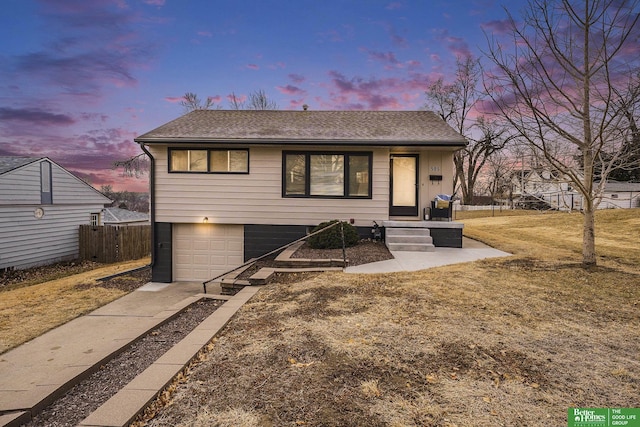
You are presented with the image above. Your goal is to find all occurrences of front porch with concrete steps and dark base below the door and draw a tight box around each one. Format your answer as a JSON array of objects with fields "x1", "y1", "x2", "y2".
[{"x1": 382, "y1": 220, "x2": 464, "y2": 252}]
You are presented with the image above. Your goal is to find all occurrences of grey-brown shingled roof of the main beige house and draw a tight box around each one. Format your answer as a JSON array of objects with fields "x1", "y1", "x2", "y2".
[{"x1": 134, "y1": 110, "x2": 467, "y2": 147}]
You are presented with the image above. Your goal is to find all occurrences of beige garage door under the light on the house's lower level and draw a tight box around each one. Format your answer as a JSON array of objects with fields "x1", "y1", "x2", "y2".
[{"x1": 173, "y1": 224, "x2": 244, "y2": 282}]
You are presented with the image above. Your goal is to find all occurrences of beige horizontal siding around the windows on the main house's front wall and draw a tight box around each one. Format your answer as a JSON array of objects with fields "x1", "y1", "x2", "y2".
[{"x1": 151, "y1": 145, "x2": 389, "y2": 227}]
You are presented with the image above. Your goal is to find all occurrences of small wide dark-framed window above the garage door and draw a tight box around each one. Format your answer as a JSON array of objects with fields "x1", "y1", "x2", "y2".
[{"x1": 169, "y1": 149, "x2": 249, "y2": 173}]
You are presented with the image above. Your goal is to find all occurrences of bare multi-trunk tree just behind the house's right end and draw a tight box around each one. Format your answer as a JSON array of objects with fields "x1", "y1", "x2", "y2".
[{"x1": 426, "y1": 56, "x2": 511, "y2": 204}]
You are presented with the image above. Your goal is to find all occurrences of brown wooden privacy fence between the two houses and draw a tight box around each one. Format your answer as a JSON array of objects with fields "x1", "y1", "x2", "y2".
[{"x1": 80, "y1": 225, "x2": 151, "y2": 264}]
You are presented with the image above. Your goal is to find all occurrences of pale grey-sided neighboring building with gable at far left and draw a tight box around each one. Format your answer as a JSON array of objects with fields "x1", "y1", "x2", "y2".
[{"x1": 0, "y1": 156, "x2": 111, "y2": 271}]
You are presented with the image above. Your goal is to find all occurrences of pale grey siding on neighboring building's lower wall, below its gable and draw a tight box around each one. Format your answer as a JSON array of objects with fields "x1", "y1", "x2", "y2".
[{"x1": 0, "y1": 204, "x2": 103, "y2": 269}]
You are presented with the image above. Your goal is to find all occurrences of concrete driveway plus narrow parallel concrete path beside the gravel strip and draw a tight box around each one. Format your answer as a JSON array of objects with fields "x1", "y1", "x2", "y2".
[{"x1": 0, "y1": 283, "x2": 259, "y2": 426}]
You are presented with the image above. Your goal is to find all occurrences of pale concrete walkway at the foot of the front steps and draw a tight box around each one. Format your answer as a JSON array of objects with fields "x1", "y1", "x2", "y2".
[{"x1": 345, "y1": 237, "x2": 511, "y2": 273}]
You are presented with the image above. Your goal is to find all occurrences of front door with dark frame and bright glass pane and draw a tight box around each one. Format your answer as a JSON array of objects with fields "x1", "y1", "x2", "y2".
[{"x1": 389, "y1": 154, "x2": 418, "y2": 216}]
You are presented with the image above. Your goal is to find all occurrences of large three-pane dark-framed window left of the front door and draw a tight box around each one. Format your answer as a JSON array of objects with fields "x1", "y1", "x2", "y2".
[{"x1": 282, "y1": 152, "x2": 372, "y2": 198}]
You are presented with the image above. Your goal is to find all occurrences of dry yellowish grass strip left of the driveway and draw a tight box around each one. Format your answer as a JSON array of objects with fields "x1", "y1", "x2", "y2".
[{"x1": 0, "y1": 258, "x2": 149, "y2": 353}]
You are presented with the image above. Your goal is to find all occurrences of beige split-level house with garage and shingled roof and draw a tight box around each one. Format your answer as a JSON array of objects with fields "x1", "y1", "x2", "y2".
[{"x1": 135, "y1": 110, "x2": 467, "y2": 282}]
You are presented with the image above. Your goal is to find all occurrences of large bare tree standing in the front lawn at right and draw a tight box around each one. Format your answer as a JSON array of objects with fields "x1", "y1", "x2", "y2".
[{"x1": 486, "y1": 0, "x2": 639, "y2": 266}]
